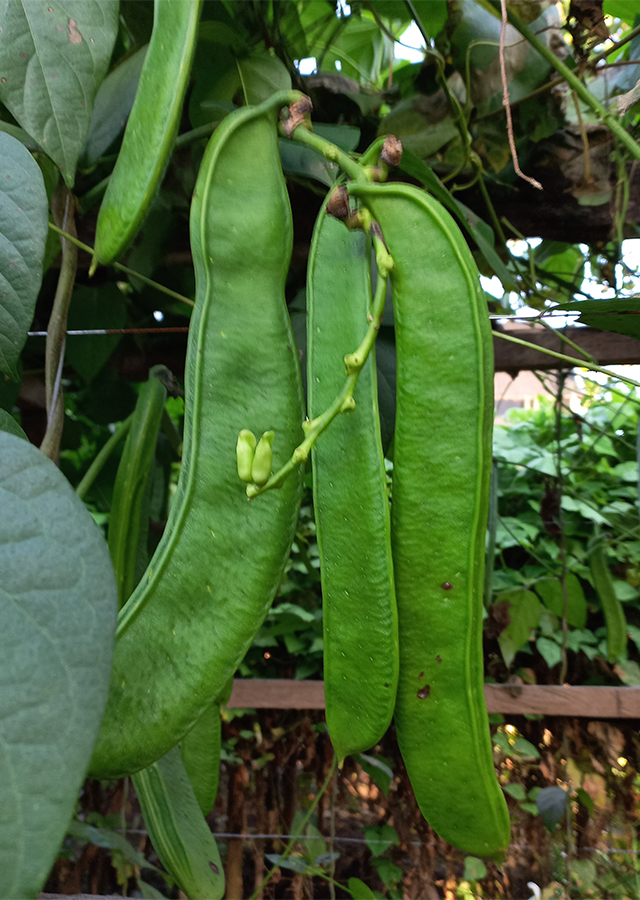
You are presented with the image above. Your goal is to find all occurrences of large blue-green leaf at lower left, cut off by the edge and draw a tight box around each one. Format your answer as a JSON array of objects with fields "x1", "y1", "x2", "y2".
[{"x1": 0, "y1": 432, "x2": 117, "y2": 898}]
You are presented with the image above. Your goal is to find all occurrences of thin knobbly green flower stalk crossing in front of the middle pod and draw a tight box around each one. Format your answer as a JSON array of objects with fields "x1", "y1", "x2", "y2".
[{"x1": 247, "y1": 243, "x2": 387, "y2": 498}]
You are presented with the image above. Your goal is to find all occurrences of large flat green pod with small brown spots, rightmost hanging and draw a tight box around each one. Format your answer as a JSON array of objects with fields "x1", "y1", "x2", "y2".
[{"x1": 353, "y1": 184, "x2": 509, "y2": 859}]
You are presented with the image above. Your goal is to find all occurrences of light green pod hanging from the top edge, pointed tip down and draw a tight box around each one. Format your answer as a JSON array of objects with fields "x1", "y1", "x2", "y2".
[{"x1": 92, "y1": 0, "x2": 202, "y2": 269}]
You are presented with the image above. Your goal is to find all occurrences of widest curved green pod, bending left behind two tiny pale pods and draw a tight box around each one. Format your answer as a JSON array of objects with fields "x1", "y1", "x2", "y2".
[{"x1": 90, "y1": 92, "x2": 303, "y2": 777}]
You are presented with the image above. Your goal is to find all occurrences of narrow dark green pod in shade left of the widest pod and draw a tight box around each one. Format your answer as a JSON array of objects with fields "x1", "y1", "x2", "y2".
[{"x1": 109, "y1": 366, "x2": 168, "y2": 609}]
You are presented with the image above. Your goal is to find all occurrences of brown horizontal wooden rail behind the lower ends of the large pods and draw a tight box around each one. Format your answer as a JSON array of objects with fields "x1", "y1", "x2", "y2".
[{"x1": 229, "y1": 678, "x2": 640, "y2": 719}]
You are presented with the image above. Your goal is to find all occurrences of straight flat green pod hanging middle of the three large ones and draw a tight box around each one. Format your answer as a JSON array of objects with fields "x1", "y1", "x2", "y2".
[{"x1": 307, "y1": 210, "x2": 398, "y2": 760}]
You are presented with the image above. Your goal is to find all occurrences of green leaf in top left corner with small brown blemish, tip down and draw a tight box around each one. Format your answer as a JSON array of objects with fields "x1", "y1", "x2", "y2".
[{"x1": 0, "y1": 0, "x2": 118, "y2": 187}]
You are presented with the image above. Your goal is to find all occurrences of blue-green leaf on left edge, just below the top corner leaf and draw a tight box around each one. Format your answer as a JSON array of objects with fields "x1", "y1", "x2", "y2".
[{"x1": 0, "y1": 132, "x2": 48, "y2": 380}]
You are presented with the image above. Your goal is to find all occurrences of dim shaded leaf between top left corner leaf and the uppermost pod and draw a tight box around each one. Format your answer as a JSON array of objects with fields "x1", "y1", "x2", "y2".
[{"x1": 80, "y1": 47, "x2": 147, "y2": 167}]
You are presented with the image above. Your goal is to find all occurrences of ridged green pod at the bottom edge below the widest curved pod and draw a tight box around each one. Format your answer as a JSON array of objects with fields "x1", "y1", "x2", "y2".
[{"x1": 132, "y1": 747, "x2": 224, "y2": 900}]
